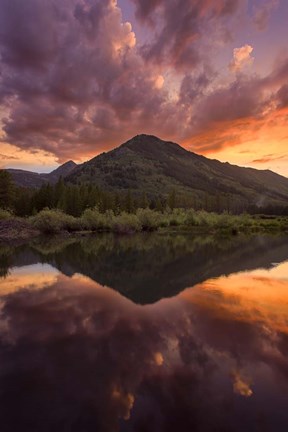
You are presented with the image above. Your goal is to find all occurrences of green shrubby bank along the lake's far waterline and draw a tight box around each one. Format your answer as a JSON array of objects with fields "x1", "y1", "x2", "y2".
[{"x1": 0, "y1": 208, "x2": 288, "y2": 234}]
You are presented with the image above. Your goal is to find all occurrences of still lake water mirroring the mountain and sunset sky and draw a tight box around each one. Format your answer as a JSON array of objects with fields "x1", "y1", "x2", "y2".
[{"x1": 0, "y1": 235, "x2": 288, "y2": 432}]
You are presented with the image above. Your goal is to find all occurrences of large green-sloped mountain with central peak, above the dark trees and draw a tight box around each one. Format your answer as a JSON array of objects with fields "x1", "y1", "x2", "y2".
[{"x1": 66, "y1": 135, "x2": 288, "y2": 209}]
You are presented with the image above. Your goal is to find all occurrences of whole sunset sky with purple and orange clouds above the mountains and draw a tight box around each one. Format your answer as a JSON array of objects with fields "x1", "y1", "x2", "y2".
[{"x1": 0, "y1": 0, "x2": 288, "y2": 176}]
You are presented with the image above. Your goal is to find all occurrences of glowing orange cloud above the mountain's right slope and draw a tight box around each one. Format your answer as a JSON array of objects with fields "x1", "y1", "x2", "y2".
[{"x1": 183, "y1": 108, "x2": 288, "y2": 176}]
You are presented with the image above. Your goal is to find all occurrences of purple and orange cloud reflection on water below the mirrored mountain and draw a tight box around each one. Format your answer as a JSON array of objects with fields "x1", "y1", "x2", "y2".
[{"x1": 0, "y1": 264, "x2": 288, "y2": 432}]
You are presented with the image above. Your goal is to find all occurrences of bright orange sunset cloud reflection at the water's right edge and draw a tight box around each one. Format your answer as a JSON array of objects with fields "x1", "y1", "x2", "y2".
[{"x1": 179, "y1": 263, "x2": 288, "y2": 333}]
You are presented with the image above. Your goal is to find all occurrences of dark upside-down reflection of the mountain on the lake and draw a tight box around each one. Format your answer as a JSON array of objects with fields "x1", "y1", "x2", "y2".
[{"x1": 3, "y1": 234, "x2": 288, "y2": 304}]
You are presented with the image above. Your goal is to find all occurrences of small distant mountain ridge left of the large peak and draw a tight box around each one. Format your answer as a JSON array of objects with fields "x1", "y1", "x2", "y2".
[{"x1": 7, "y1": 161, "x2": 77, "y2": 188}]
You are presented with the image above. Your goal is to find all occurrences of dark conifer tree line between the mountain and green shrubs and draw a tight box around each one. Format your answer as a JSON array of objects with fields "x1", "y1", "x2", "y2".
[{"x1": 0, "y1": 170, "x2": 288, "y2": 217}]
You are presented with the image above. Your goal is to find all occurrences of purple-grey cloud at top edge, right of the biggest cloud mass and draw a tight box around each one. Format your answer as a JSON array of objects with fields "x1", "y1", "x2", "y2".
[{"x1": 133, "y1": 0, "x2": 240, "y2": 70}]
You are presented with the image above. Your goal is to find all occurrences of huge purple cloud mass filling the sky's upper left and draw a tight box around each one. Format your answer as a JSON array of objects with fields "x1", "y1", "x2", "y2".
[{"x1": 0, "y1": 0, "x2": 174, "y2": 160}]
